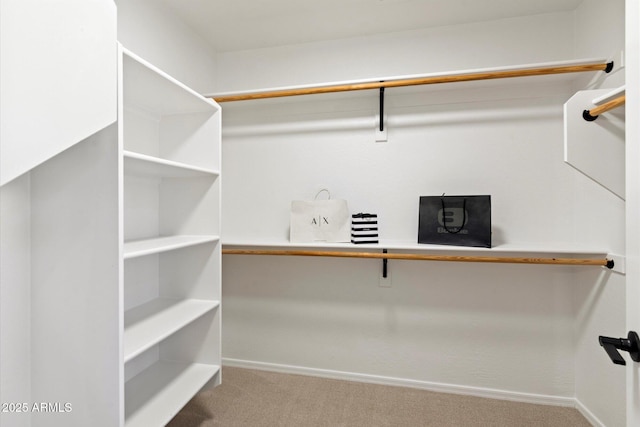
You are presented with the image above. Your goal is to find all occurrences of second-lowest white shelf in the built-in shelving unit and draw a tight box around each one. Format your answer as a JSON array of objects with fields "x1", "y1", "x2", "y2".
[{"x1": 124, "y1": 298, "x2": 220, "y2": 362}]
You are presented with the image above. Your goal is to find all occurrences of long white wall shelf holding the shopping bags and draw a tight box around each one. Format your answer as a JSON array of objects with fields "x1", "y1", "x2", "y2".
[{"x1": 222, "y1": 240, "x2": 609, "y2": 258}]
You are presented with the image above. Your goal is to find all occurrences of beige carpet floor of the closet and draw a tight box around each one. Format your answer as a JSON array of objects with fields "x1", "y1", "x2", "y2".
[{"x1": 168, "y1": 367, "x2": 590, "y2": 427}]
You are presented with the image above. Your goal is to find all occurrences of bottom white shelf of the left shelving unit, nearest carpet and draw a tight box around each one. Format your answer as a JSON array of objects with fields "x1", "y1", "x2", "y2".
[{"x1": 125, "y1": 362, "x2": 220, "y2": 427}]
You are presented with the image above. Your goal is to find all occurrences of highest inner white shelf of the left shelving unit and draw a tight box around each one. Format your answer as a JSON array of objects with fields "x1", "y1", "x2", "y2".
[{"x1": 124, "y1": 151, "x2": 219, "y2": 178}]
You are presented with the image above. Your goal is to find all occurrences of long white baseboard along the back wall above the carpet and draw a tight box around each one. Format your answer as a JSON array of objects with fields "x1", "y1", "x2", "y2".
[{"x1": 222, "y1": 358, "x2": 576, "y2": 408}]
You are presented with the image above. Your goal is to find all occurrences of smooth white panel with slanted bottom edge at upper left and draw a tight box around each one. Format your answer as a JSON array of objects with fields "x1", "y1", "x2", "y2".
[{"x1": 0, "y1": 0, "x2": 117, "y2": 185}]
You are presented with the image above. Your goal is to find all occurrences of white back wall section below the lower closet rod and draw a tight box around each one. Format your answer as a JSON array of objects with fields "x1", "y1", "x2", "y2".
[{"x1": 223, "y1": 256, "x2": 573, "y2": 403}]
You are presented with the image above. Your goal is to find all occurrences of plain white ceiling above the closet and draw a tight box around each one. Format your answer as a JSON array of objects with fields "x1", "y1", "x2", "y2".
[{"x1": 160, "y1": 0, "x2": 582, "y2": 52}]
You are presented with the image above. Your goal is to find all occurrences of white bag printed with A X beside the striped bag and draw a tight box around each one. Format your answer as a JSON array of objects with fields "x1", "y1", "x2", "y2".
[{"x1": 289, "y1": 189, "x2": 351, "y2": 243}]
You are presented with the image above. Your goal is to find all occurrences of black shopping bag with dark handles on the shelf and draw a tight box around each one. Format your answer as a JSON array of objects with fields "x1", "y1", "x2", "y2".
[{"x1": 418, "y1": 195, "x2": 491, "y2": 248}]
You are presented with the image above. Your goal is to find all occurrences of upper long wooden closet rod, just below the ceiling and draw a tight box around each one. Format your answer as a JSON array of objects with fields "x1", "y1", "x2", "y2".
[{"x1": 212, "y1": 62, "x2": 613, "y2": 102}]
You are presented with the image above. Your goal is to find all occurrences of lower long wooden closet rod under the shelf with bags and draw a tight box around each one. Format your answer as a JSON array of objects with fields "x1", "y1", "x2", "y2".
[{"x1": 222, "y1": 249, "x2": 614, "y2": 269}]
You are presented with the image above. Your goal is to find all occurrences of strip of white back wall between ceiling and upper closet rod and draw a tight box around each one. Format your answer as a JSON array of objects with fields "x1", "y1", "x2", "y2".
[{"x1": 217, "y1": 13, "x2": 573, "y2": 92}]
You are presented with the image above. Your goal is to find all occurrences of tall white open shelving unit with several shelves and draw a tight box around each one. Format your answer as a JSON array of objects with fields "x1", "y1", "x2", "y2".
[{"x1": 119, "y1": 48, "x2": 221, "y2": 426}]
